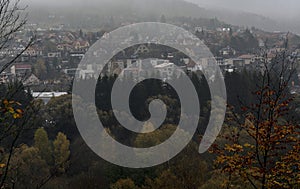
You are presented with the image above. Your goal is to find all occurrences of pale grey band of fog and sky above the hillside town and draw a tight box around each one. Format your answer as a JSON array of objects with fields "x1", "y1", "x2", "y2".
[{"x1": 24, "y1": 0, "x2": 300, "y2": 34}]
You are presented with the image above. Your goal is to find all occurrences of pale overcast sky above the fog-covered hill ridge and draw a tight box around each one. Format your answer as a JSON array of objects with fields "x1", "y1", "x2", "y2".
[{"x1": 22, "y1": 0, "x2": 300, "y2": 20}]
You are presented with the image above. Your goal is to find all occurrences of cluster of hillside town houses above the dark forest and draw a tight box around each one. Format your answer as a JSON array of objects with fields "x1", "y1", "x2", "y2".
[{"x1": 0, "y1": 22, "x2": 300, "y2": 93}]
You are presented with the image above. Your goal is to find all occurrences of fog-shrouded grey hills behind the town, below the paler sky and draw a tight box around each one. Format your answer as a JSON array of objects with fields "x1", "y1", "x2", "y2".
[{"x1": 22, "y1": 0, "x2": 300, "y2": 33}]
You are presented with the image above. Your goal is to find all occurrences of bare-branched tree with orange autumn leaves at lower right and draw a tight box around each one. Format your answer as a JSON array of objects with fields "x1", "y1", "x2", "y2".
[{"x1": 211, "y1": 51, "x2": 300, "y2": 188}]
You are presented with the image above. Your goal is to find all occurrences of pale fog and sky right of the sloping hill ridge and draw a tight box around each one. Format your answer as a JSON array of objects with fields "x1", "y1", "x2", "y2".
[{"x1": 186, "y1": 0, "x2": 300, "y2": 34}]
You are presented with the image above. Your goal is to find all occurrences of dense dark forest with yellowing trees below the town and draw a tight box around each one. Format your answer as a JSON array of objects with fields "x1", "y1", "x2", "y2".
[{"x1": 1, "y1": 57, "x2": 300, "y2": 188}]
